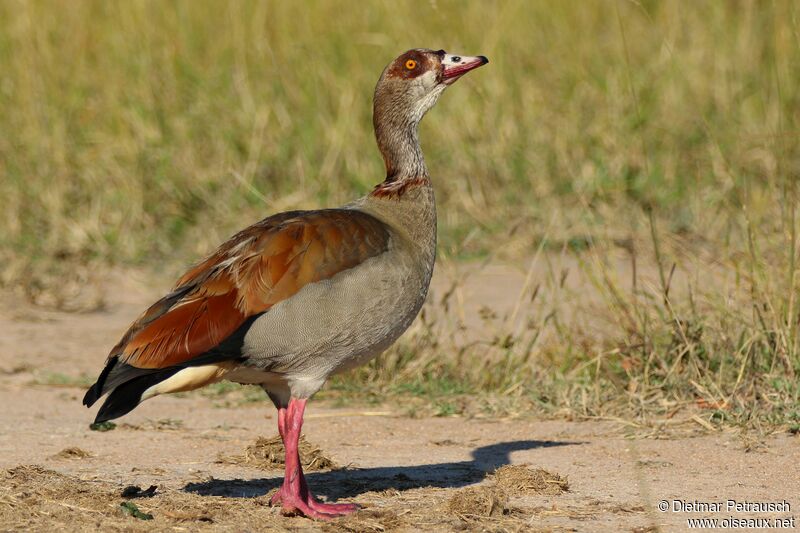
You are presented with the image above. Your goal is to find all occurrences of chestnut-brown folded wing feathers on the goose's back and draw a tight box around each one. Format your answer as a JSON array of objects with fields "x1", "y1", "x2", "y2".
[{"x1": 109, "y1": 209, "x2": 389, "y2": 369}]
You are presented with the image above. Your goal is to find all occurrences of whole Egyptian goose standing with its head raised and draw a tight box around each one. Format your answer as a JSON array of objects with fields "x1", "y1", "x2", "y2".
[{"x1": 83, "y1": 49, "x2": 488, "y2": 519}]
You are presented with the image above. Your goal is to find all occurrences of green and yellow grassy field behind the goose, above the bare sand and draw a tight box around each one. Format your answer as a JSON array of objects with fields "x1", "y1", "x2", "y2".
[{"x1": 0, "y1": 0, "x2": 800, "y2": 430}]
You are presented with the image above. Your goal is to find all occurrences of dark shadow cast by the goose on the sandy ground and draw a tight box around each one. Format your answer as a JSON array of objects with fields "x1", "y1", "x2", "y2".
[{"x1": 183, "y1": 440, "x2": 583, "y2": 501}]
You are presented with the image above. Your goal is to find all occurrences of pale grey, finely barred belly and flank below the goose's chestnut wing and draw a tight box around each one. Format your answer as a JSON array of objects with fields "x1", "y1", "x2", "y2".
[{"x1": 242, "y1": 251, "x2": 433, "y2": 382}]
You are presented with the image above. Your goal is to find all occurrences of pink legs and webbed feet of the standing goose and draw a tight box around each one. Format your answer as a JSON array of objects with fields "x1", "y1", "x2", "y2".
[{"x1": 271, "y1": 398, "x2": 358, "y2": 519}]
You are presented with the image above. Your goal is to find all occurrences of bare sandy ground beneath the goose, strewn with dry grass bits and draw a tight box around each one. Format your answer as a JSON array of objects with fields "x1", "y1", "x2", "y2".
[{"x1": 0, "y1": 270, "x2": 800, "y2": 531}]
